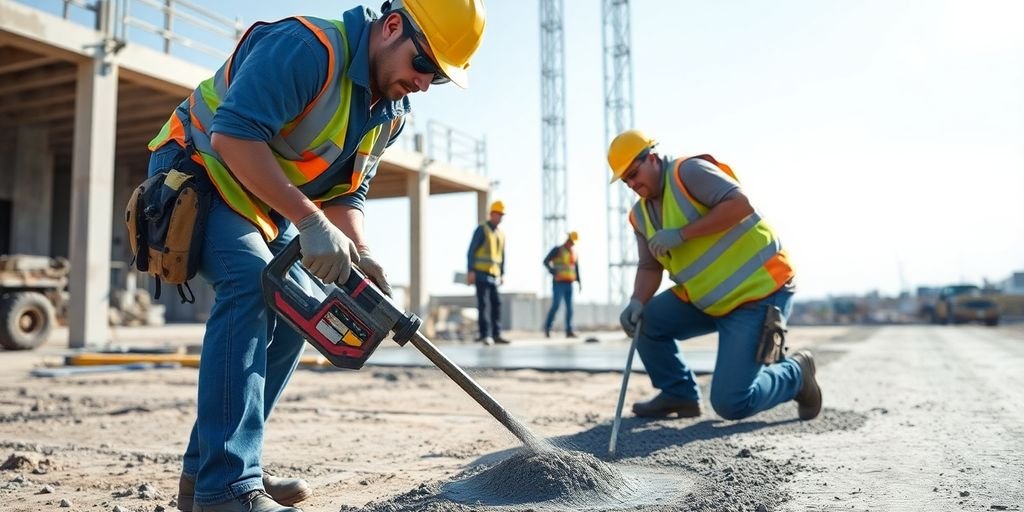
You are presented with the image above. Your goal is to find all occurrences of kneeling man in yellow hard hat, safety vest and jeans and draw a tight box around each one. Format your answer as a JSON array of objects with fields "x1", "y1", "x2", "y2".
[{"x1": 608, "y1": 130, "x2": 821, "y2": 420}]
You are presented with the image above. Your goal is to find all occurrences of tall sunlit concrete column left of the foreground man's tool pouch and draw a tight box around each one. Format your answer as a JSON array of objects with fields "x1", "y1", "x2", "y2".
[{"x1": 68, "y1": 55, "x2": 118, "y2": 348}]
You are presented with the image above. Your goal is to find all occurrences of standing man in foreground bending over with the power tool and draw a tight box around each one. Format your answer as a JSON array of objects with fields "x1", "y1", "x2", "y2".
[{"x1": 142, "y1": 0, "x2": 485, "y2": 512}]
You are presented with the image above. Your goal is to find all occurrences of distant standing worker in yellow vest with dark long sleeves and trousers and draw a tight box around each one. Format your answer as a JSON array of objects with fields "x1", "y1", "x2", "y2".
[{"x1": 466, "y1": 201, "x2": 509, "y2": 345}]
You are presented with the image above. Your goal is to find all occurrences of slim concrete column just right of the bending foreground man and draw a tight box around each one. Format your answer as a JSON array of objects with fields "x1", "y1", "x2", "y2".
[{"x1": 407, "y1": 163, "x2": 430, "y2": 318}]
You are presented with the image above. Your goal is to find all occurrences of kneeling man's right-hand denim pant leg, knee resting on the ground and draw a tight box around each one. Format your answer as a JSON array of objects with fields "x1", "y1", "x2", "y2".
[{"x1": 711, "y1": 291, "x2": 803, "y2": 420}]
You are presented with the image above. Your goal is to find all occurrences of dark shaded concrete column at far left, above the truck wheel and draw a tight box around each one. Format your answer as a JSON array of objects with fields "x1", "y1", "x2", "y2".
[{"x1": 10, "y1": 125, "x2": 53, "y2": 256}]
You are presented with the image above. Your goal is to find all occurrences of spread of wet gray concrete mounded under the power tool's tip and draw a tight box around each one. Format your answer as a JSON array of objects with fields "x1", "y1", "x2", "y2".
[{"x1": 341, "y1": 408, "x2": 866, "y2": 512}]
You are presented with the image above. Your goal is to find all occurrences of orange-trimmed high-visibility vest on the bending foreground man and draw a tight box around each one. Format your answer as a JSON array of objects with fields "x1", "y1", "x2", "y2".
[{"x1": 150, "y1": 16, "x2": 401, "y2": 241}]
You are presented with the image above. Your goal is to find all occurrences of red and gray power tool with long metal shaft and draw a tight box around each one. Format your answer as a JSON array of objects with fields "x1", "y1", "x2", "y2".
[{"x1": 263, "y1": 237, "x2": 544, "y2": 449}]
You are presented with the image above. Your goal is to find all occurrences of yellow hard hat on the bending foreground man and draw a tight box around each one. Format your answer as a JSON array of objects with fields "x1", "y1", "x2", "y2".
[{"x1": 391, "y1": 0, "x2": 487, "y2": 88}]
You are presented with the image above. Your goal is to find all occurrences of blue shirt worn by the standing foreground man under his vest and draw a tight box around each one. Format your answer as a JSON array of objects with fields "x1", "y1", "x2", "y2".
[{"x1": 211, "y1": 7, "x2": 412, "y2": 210}]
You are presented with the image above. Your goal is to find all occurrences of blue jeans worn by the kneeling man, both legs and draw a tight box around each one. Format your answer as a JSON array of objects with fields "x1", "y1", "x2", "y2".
[{"x1": 637, "y1": 290, "x2": 803, "y2": 420}]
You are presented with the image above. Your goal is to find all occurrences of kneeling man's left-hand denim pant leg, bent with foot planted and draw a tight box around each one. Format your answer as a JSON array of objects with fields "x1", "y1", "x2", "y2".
[{"x1": 637, "y1": 290, "x2": 715, "y2": 400}]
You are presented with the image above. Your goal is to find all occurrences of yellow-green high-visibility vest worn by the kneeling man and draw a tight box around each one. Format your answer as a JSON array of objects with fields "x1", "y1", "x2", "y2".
[{"x1": 630, "y1": 155, "x2": 795, "y2": 316}]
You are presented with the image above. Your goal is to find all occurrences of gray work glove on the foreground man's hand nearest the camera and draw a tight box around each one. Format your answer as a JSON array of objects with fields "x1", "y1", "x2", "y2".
[{"x1": 295, "y1": 211, "x2": 359, "y2": 285}]
